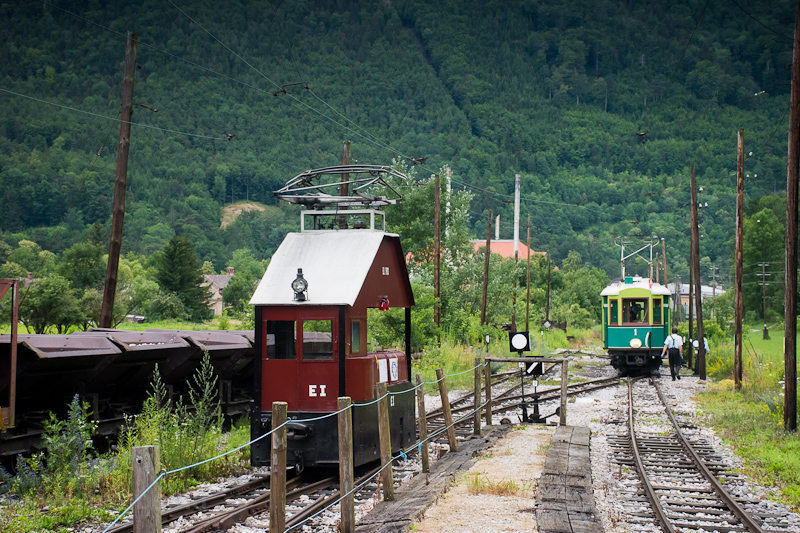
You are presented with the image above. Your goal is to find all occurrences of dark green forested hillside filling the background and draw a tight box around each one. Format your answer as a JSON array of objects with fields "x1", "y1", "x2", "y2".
[{"x1": 0, "y1": 0, "x2": 794, "y2": 276}]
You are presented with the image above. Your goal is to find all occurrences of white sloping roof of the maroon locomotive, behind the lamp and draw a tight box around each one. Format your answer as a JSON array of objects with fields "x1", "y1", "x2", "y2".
[{"x1": 250, "y1": 230, "x2": 397, "y2": 306}]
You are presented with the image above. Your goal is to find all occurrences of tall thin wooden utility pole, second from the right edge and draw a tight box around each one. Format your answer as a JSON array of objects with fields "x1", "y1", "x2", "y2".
[{"x1": 733, "y1": 130, "x2": 744, "y2": 391}]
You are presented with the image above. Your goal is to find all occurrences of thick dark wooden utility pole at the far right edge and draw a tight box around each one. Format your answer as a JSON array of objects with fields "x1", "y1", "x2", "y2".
[{"x1": 783, "y1": 3, "x2": 800, "y2": 431}]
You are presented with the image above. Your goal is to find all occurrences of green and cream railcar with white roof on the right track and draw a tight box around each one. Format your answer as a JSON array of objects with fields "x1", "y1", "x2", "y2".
[{"x1": 600, "y1": 276, "x2": 672, "y2": 375}]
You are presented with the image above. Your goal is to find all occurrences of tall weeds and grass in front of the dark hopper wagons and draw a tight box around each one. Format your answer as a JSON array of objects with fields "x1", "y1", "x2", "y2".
[{"x1": 0, "y1": 352, "x2": 250, "y2": 533}]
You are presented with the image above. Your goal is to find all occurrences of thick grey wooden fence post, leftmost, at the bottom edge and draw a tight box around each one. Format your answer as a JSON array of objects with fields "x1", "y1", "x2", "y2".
[{"x1": 131, "y1": 446, "x2": 161, "y2": 533}]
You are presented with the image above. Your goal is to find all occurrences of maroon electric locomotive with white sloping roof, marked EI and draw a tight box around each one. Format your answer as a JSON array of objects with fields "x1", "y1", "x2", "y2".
[{"x1": 250, "y1": 167, "x2": 416, "y2": 471}]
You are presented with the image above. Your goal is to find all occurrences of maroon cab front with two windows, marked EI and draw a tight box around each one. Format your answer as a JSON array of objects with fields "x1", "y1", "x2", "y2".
[{"x1": 261, "y1": 308, "x2": 339, "y2": 412}]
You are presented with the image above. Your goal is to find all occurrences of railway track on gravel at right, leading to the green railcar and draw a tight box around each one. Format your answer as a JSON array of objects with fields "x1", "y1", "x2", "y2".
[{"x1": 609, "y1": 379, "x2": 791, "y2": 533}]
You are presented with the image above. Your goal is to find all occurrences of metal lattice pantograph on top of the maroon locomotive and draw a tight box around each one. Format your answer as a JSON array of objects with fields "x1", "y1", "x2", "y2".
[{"x1": 274, "y1": 165, "x2": 408, "y2": 209}]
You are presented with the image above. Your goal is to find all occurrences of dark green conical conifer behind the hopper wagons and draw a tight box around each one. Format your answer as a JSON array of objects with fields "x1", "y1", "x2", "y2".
[{"x1": 153, "y1": 236, "x2": 212, "y2": 322}]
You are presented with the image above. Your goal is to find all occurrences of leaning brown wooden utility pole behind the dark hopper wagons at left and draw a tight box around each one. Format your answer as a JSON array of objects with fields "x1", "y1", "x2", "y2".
[{"x1": 100, "y1": 31, "x2": 137, "y2": 328}]
